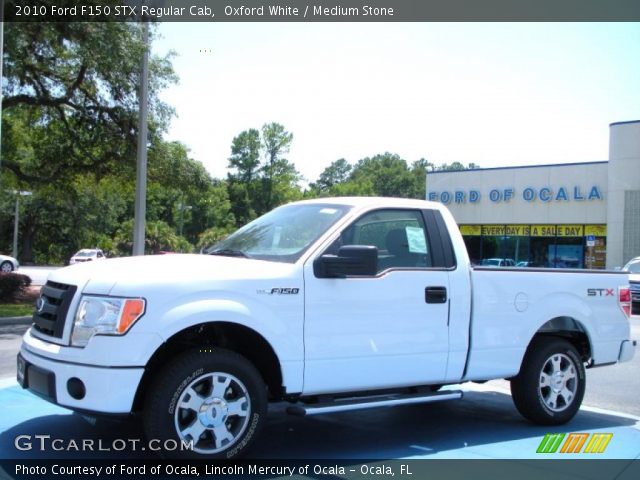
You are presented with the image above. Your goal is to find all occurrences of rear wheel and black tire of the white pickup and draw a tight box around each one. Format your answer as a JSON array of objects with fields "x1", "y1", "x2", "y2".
[{"x1": 511, "y1": 337, "x2": 586, "y2": 425}]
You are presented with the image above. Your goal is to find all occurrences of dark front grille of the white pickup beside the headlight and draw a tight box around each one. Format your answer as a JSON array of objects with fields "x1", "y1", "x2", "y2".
[{"x1": 33, "y1": 282, "x2": 77, "y2": 338}]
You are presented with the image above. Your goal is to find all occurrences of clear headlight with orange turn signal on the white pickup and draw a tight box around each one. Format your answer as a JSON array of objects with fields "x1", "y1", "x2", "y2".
[{"x1": 71, "y1": 296, "x2": 145, "y2": 347}]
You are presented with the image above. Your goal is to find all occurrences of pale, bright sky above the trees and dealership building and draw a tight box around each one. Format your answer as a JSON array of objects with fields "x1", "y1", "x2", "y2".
[{"x1": 152, "y1": 22, "x2": 640, "y2": 182}]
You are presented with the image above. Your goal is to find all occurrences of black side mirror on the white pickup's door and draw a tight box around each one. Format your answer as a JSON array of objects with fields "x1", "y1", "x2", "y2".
[{"x1": 313, "y1": 245, "x2": 378, "y2": 278}]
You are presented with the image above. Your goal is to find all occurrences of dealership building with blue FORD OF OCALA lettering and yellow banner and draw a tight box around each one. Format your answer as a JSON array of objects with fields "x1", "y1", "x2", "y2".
[{"x1": 427, "y1": 120, "x2": 640, "y2": 269}]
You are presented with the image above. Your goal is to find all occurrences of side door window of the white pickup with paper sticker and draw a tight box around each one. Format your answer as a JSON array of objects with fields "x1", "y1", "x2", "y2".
[{"x1": 326, "y1": 210, "x2": 432, "y2": 273}]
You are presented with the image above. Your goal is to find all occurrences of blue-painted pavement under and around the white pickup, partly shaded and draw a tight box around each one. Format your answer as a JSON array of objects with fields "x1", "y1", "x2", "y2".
[{"x1": 0, "y1": 380, "x2": 640, "y2": 462}]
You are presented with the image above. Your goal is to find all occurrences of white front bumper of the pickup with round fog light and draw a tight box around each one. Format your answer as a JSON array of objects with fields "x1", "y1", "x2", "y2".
[{"x1": 18, "y1": 347, "x2": 144, "y2": 414}]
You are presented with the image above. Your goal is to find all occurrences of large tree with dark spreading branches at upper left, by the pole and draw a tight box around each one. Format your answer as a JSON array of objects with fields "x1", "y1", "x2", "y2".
[{"x1": 0, "y1": 22, "x2": 182, "y2": 263}]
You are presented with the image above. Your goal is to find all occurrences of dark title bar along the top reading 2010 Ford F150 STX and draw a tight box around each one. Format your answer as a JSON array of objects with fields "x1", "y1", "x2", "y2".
[{"x1": 4, "y1": 0, "x2": 640, "y2": 22}]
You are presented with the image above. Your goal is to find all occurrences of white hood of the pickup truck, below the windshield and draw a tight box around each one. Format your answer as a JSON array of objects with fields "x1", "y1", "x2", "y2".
[{"x1": 49, "y1": 254, "x2": 296, "y2": 296}]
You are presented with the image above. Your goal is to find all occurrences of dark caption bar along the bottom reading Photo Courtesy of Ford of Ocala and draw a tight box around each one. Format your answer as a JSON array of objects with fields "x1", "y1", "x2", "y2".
[{"x1": 0, "y1": 458, "x2": 640, "y2": 480}]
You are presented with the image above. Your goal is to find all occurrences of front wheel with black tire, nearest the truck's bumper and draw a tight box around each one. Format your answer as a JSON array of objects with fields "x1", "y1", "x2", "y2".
[{"x1": 143, "y1": 348, "x2": 267, "y2": 459}]
